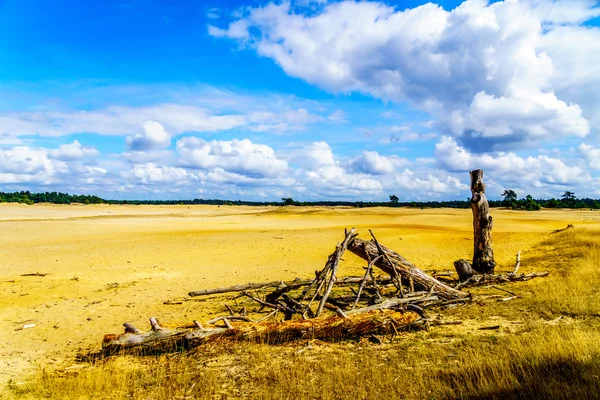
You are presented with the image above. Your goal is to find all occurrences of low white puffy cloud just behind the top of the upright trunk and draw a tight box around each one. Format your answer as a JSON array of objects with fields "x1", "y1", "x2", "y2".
[{"x1": 435, "y1": 136, "x2": 591, "y2": 187}]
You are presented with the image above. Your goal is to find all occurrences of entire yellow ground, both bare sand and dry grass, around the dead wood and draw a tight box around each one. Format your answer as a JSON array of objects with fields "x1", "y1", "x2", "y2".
[{"x1": 0, "y1": 205, "x2": 600, "y2": 399}]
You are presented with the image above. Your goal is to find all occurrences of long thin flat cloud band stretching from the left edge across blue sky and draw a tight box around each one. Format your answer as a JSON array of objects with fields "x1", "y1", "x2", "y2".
[{"x1": 0, "y1": 101, "x2": 340, "y2": 139}]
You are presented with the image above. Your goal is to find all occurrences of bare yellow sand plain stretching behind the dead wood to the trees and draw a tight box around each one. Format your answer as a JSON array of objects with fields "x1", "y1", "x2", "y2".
[{"x1": 0, "y1": 204, "x2": 600, "y2": 386}]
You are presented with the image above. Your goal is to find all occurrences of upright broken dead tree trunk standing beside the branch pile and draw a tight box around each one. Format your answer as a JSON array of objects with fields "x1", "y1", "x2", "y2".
[{"x1": 470, "y1": 169, "x2": 496, "y2": 274}]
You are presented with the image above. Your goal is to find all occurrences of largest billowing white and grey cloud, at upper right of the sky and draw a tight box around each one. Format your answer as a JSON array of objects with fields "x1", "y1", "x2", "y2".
[{"x1": 209, "y1": 0, "x2": 600, "y2": 151}]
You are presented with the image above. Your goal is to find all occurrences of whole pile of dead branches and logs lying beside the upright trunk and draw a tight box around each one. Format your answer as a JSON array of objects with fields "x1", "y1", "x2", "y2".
[{"x1": 103, "y1": 228, "x2": 547, "y2": 354}]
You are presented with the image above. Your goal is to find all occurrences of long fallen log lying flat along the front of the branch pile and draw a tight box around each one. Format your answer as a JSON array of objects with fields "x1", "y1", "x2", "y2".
[{"x1": 102, "y1": 310, "x2": 426, "y2": 355}]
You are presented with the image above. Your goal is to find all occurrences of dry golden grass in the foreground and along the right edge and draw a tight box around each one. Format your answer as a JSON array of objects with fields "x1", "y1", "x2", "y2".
[{"x1": 11, "y1": 223, "x2": 600, "y2": 399}]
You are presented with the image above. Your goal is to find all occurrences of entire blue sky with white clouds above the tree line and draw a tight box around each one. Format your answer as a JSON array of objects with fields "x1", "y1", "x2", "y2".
[{"x1": 0, "y1": 0, "x2": 600, "y2": 201}]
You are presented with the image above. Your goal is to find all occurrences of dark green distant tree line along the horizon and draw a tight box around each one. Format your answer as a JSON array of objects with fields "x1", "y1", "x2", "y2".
[{"x1": 0, "y1": 189, "x2": 600, "y2": 211}]
